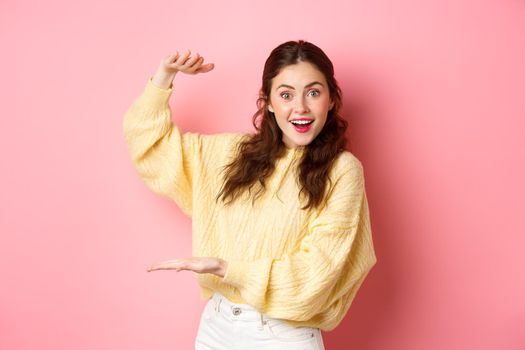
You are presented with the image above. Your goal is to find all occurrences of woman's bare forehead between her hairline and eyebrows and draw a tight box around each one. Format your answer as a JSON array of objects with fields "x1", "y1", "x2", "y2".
[{"x1": 272, "y1": 62, "x2": 326, "y2": 88}]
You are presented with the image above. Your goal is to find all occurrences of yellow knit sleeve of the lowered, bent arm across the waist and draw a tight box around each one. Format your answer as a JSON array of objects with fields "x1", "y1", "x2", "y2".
[{"x1": 223, "y1": 161, "x2": 376, "y2": 321}]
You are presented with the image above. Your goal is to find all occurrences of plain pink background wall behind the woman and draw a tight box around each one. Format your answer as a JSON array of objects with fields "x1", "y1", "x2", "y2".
[{"x1": 0, "y1": 0, "x2": 525, "y2": 350}]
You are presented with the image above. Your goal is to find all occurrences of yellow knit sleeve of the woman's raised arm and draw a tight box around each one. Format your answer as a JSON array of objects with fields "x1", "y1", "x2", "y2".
[{"x1": 123, "y1": 77, "x2": 203, "y2": 217}]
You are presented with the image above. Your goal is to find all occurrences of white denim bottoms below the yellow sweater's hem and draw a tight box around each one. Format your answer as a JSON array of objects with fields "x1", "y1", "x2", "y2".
[{"x1": 195, "y1": 293, "x2": 324, "y2": 350}]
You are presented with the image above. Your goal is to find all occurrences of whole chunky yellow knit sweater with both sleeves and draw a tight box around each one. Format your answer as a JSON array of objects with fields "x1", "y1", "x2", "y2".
[{"x1": 123, "y1": 77, "x2": 377, "y2": 331}]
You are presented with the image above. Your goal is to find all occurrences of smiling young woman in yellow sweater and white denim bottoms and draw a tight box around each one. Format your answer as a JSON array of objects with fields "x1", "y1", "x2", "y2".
[{"x1": 123, "y1": 40, "x2": 376, "y2": 350}]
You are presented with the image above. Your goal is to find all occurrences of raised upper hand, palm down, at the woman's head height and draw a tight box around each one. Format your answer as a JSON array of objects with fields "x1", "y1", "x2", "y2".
[{"x1": 152, "y1": 50, "x2": 215, "y2": 89}]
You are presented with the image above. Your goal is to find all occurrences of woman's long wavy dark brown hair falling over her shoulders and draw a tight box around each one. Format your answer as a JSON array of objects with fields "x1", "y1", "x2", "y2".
[{"x1": 217, "y1": 40, "x2": 348, "y2": 209}]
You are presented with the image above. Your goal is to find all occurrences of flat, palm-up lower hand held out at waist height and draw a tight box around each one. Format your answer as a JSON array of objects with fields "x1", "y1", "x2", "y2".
[{"x1": 147, "y1": 257, "x2": 228, "y2": 277}]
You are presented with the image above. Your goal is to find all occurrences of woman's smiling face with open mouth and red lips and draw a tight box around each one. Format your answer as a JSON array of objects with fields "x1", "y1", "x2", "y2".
[{"x1": 268, "y1": 62, "x2": 334, "y2": 148}]
